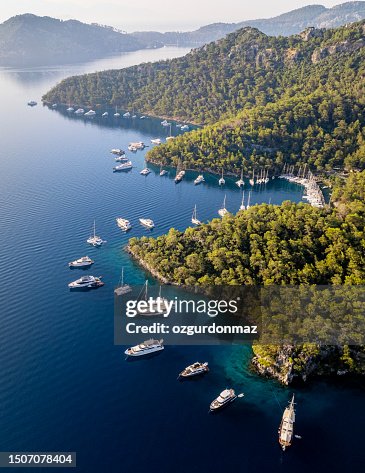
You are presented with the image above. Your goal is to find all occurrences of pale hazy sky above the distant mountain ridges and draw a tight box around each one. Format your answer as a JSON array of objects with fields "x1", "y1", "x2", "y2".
[{"x1": 0, "y1": 0, "x2": 344, "y2": 31}]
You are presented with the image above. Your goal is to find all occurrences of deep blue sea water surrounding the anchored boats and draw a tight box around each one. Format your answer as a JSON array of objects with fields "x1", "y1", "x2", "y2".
[{"x1": 0, "y1": 48, "x2": 365, "y2": 473}]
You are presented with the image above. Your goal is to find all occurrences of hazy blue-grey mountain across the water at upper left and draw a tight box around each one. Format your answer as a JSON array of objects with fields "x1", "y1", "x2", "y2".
[{"x1": 0, "y1": 14, "x2": 147, "y2": 66}]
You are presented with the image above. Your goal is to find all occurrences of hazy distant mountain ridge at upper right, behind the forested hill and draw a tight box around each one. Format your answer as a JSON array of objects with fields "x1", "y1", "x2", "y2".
[{"x1": 132, "y1": 1, "x2": 365, "y2": 47}]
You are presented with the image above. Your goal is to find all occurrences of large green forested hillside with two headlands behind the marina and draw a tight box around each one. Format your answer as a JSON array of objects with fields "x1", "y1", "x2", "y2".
[{"x1": 44, "y1": 22, "x2": 365, "y2": 171}]
